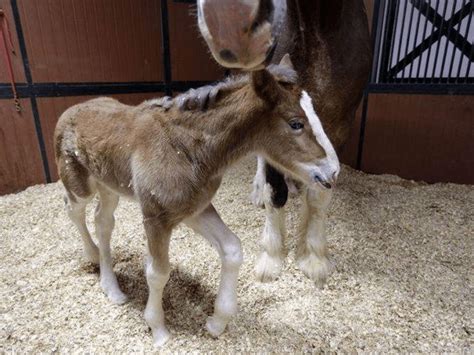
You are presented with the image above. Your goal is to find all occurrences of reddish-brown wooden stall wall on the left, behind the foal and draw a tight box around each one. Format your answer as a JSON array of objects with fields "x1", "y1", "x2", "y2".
[{"x1": 0, "y1": 0, "x2": 224, "y2": 194}]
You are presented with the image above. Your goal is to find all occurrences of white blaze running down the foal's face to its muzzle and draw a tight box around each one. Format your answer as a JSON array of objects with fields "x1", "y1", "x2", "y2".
[{"x1": 300, "y1": 90, "x2": 340, "y2": 180}]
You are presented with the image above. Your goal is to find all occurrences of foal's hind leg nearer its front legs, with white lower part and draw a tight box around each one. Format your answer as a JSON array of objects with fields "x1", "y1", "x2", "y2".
[{"x1": 95, "y1": 188, "x2": 127, "y2": 304}]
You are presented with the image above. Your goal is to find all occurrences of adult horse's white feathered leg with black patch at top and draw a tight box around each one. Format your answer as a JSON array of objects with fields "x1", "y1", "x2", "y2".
[{"x1": 255, "y1": 164, "x2": 288, "y2": 282}]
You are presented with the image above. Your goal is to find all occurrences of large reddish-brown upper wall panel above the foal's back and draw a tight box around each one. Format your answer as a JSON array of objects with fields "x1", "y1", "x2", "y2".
[{"x1": 18, "y1": 0, "x2": 162, "y2": 82}]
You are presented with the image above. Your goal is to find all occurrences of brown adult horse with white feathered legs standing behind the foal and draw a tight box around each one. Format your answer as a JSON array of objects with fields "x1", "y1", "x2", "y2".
[{"x1": 197, "y1": 0, "x2": 371, "y2": 285}]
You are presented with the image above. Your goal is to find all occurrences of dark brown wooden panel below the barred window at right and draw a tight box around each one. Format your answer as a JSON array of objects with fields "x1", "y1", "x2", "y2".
[{"x1": 362, "y1": 94, "x2": 474, "y2": 184}]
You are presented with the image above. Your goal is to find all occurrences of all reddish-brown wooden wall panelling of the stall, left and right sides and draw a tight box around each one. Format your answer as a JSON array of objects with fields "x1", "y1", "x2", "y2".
[{"x1": 0, "y1": 0, "x2": 474, "y2": 194}]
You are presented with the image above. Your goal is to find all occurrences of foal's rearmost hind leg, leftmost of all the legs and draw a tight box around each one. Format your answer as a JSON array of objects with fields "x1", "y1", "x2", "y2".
[{"x1": 64, "y1": 192, "x2": 99, "y2": 264}]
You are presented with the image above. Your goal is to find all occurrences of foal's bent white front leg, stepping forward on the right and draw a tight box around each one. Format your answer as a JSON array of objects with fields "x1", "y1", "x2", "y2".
[{"x1": 185, "y1": 205, "x2": 242, "y2": 337}]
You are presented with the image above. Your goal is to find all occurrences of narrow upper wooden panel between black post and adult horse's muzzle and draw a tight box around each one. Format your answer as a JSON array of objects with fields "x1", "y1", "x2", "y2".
[{"x1": 168, "y1": 1, "x2": 224, "y2": 80}]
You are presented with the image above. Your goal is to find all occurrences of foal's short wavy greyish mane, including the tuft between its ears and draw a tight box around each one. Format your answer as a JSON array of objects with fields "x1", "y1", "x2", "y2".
[{"x1": 140, "y1": 65, "x2": 297, "y2": 111}]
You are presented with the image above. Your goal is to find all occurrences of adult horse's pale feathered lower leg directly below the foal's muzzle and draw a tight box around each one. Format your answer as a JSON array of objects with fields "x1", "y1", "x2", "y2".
[{"x1": 296, "y1": 188, "x2": 333, "y2": 287}]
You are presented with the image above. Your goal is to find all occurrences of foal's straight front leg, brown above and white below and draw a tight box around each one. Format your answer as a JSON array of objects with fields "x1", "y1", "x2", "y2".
[{"x1": 144, "y1": 218, "x2": 171, "y2": 347}]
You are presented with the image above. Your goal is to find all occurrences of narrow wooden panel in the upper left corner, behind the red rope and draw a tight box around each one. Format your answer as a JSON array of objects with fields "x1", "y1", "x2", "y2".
[{"x1": 0, "y1": 0, "x2": 25, "y2": 83}]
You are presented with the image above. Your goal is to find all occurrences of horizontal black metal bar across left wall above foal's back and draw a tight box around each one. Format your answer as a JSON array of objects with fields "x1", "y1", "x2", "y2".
[{"x1": 0, "y1": 81, "x2": 213, "y2": 99}]
